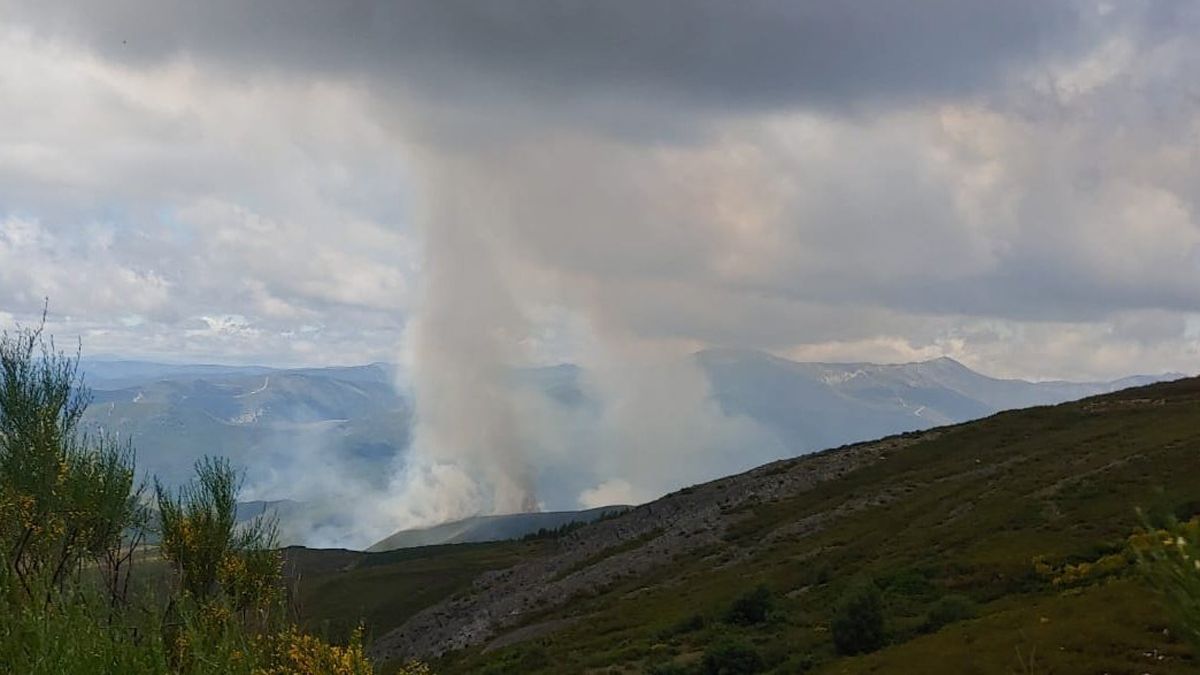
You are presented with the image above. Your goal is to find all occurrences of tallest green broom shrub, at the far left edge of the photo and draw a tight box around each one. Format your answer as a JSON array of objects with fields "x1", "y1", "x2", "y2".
[{"x1": 0, "y1": 319, "x2": 145, "y2": 602}]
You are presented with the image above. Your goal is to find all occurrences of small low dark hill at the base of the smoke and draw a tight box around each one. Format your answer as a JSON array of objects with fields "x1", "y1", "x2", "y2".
[{"x1": 367, "y1": 506, "x2": 630, "y2": 551}]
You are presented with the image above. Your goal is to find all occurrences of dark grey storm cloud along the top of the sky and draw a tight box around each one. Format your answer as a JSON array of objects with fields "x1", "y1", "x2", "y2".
[{"x1": 14, "y1": 0, "x2": 1085, "y2": 109}]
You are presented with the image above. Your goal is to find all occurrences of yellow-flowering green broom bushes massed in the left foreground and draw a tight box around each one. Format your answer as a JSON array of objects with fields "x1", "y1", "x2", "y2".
[{"x1": 0, "y1": 321, "x2": 415, "y2": 675}]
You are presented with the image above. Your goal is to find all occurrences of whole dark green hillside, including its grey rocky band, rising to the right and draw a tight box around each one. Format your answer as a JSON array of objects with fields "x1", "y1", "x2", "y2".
[{"x1": 290, "y1": 380, "x2": 1200, "y2": 674}]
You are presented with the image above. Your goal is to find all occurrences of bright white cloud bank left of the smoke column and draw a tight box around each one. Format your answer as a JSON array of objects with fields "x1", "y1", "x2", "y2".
[{"x1": 0, "y1": 28, "x2": 414, "y2": 363}]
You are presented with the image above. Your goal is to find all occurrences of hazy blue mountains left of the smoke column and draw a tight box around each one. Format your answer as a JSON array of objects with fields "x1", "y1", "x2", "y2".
[{"x1": 82, "y1": 362, "x2": 412, "y2": 484}]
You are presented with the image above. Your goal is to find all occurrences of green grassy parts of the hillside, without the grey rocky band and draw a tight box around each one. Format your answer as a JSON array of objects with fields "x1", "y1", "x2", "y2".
[{"x1": 297, "y1": 380, "x2": 1200, "y2": 674}]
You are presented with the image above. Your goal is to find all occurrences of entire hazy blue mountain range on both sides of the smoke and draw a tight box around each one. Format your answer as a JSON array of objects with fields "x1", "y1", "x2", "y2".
[{"x1": 83, "y1": 350, "x2": 1182, "y2": 545}]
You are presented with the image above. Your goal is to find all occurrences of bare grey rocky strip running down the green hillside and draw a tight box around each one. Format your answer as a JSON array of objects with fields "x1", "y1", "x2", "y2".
[{"x1": 371, "y1": 430, "x2": 940, "y2": 659}]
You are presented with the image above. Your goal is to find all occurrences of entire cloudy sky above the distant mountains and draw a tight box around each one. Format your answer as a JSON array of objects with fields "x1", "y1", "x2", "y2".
[{"x1": 0, "y1": 0, "x2": 1200, "y2": 378}]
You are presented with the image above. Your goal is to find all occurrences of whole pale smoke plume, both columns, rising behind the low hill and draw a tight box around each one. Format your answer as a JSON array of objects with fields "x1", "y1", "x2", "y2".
[{"x1": 367, "y1": 130, "x2": 781, "y2": 533}]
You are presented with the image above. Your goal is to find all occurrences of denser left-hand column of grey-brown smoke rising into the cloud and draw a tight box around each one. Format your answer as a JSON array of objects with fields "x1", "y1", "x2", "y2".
[{"x1": 392, "y1": 161, "x2": 538, "y2": 526}]
